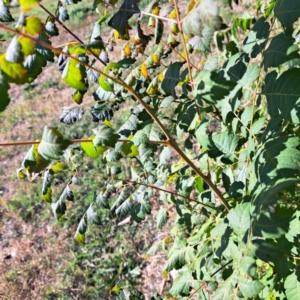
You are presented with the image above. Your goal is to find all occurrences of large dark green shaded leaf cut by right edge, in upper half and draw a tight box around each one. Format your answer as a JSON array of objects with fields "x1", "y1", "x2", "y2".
[{"x1": 262, "y1": 68, "x2": 300, "y2": 124}]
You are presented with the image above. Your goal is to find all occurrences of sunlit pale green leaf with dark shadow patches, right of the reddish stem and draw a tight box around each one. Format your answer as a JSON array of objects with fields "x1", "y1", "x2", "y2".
[{"x1": 193, "y1": 70, "x2": 236, "y2": 105}]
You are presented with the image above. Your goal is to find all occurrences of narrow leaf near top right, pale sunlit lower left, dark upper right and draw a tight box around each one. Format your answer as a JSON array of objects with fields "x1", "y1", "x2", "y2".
[{"x1": 244, "y1": 17, "x2": 270, "y2": 58}]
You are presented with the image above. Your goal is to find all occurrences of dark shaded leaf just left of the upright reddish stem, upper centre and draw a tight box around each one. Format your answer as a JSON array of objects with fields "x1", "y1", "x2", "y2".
[{"x1": 161, "y1": 62, "x2": 182, "y2": 97}]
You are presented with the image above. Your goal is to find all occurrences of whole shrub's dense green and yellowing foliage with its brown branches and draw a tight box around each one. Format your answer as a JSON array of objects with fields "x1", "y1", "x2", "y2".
[{"x1": 0, "y1": 0, "x2": 300, "y2": 300}]
